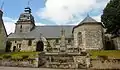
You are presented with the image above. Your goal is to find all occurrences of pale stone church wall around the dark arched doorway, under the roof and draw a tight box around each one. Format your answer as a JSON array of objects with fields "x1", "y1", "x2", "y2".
[{"x1": 10, "y1": 38, "x2": 47, "y2": 51}]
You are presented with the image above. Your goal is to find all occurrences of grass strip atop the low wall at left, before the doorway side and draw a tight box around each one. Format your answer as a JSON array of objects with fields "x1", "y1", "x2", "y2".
[{"x1": 0, "y1": 52, "x2": 39, "y2": 59}]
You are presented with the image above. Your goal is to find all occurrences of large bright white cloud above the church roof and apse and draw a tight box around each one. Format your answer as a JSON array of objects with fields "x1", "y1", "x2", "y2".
[{"x1": 37, "y1": 0, "x2": 109, "y2": 24}]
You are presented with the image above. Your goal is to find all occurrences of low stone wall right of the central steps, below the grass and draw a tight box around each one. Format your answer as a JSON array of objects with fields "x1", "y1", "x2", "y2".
[{"x1": 91, "y1": 59, "x2": 120, "y2": 69}]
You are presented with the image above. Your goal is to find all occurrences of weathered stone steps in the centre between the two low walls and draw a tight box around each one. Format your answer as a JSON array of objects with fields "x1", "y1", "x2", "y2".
[{"x1": 45, "y1": 54, "x2": 86, "y2": 69}]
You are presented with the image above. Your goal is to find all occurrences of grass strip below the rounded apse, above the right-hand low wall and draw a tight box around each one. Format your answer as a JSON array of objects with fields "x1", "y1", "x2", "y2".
[{"x1": 89, "y1": 50, "x2": 120, "y2": 59}]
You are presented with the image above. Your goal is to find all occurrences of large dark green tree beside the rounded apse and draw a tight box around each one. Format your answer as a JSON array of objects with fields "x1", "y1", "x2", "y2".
[{"x1": 101, "y1": 0, "x2": 120, "y2": 36}]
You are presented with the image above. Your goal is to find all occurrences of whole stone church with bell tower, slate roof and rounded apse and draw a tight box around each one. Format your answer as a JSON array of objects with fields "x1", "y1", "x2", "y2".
[{"x1": 8, "y1": 7, "x2": 119, "y2": 52}]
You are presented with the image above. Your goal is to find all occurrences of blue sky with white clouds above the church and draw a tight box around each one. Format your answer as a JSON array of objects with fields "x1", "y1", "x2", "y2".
[{"x1": 0, "y1": 0, "x2": 109, "y2": 34}]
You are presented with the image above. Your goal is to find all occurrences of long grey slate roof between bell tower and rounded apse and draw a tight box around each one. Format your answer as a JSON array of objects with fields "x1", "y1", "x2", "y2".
[{"x1": 8, "y1": 26, "x2": 74, "y2": 39}]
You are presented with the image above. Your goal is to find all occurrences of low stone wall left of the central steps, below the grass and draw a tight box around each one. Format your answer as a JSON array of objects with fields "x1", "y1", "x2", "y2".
[{"x1": 0, "y1": 58, "x2": 38, "y2": 67}]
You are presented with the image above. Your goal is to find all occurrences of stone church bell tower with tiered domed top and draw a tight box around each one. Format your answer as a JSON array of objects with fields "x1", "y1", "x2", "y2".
[{"x1": 15, "y1": 7, "x2": 35, "y2": 33}]
